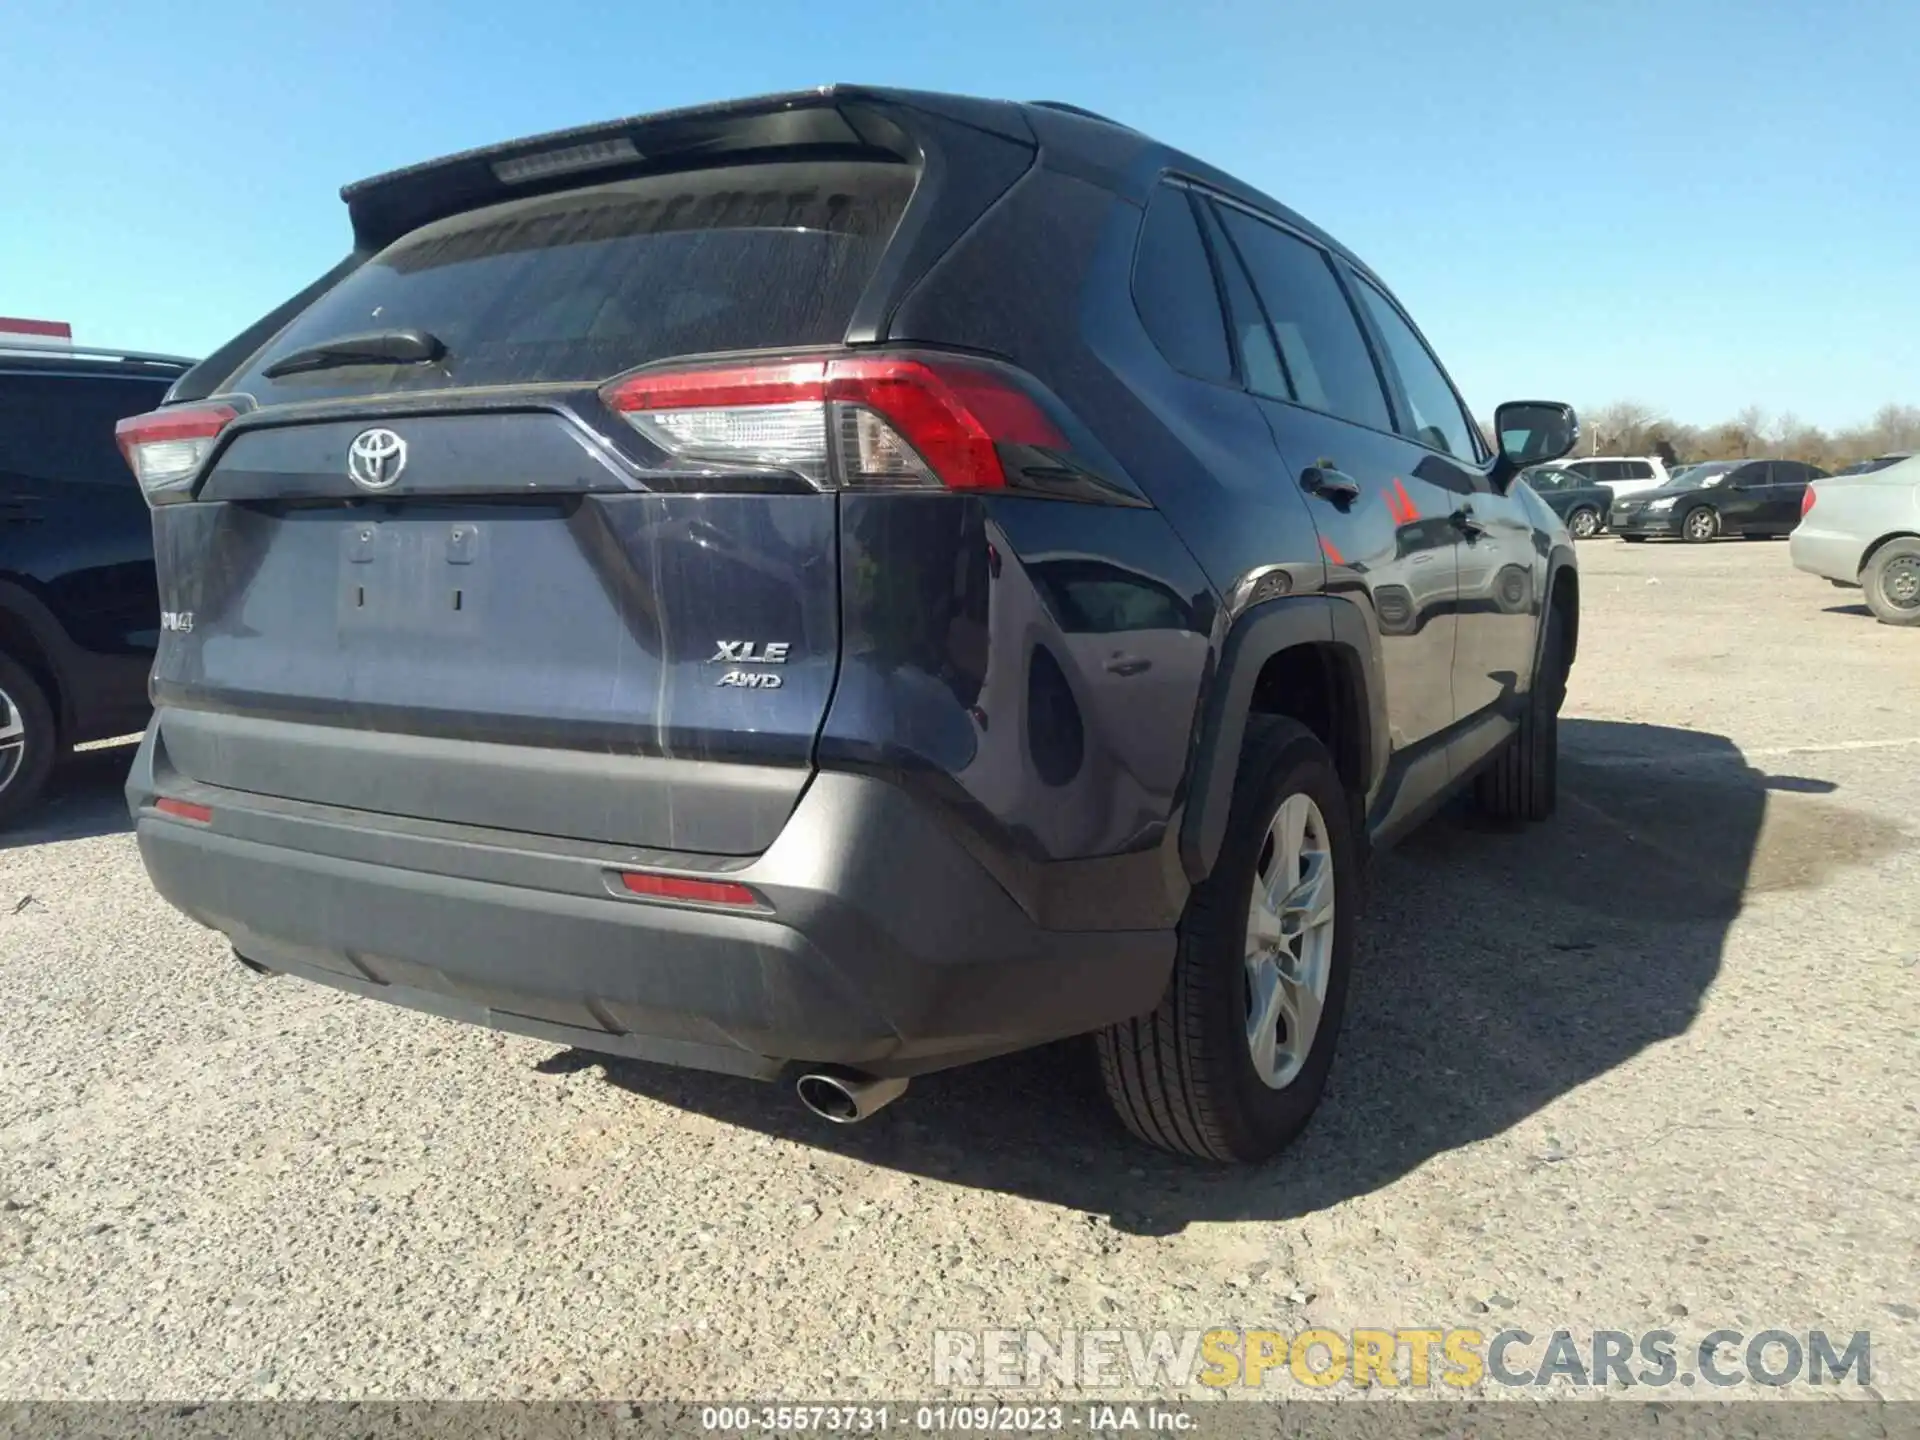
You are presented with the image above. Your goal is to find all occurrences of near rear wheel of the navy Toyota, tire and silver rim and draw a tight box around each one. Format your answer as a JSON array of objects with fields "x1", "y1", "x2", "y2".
[{"x1": 1098, "y1": 716, "x2": 1361, "y2": 1164}]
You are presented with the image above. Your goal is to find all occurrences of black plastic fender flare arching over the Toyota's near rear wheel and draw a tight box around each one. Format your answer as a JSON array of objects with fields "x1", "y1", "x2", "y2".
[{"x1": 1179, "y1": 595, "x2": 1388, "y2": 885}]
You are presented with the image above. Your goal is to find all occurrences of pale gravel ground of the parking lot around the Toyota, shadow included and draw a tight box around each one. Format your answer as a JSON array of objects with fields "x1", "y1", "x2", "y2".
[{"x1": 0, "y1": 540, "x2": 1920, "y2": 1398}]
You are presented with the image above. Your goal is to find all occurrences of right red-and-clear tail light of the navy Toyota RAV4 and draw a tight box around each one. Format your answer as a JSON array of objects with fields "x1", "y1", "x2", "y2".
[{"x1": 603, "y1": 355, "x2": 1068, "y2": 490}]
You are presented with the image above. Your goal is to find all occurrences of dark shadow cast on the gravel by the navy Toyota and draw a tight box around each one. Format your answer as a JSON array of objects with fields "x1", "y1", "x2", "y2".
[{"x1": 557, "y1": 720, "x2": 1901, "y2": 1235}]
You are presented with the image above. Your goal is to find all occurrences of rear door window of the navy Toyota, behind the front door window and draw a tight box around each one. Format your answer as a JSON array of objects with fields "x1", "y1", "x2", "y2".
[{"x1": 1217, "y1": 207, "x2": 1394, "y2": 430}]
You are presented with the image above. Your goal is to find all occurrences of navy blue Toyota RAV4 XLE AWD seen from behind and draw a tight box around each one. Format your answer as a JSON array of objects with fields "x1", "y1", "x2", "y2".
[{"x1": 123, "y1": 88, "x2": 1578, "y2": 1160}]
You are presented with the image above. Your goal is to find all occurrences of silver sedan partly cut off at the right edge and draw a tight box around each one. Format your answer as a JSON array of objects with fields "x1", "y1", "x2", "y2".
[{"x1": 1789, "y1": 457, "x2": 1920, "y2": 626}]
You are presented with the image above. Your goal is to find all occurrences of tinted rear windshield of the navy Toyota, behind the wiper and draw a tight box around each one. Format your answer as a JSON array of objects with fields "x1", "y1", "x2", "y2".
[{"x1": 223, "y1": 161, "x2": 916, "y2": 405}]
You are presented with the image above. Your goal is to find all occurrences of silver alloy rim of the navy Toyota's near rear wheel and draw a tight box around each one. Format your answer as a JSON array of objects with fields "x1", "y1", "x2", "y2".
[{"x1": 1246, "y1": 795, "x2": 1334, "y2": 1091}]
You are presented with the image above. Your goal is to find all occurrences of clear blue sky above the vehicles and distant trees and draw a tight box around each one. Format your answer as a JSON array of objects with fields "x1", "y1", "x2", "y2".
[{"x1": 0, "y1": 0, "x2": 1920, "y2": 426}]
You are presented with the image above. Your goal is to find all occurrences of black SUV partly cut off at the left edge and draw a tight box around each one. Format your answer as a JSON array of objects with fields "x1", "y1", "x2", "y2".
[{"x1": 0, "y1": 349, "x2": 192, "y2": 826}]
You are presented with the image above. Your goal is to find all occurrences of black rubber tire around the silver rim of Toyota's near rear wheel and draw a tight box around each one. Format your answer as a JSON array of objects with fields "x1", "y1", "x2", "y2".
[{"x1": 1096, "y1": 716, "x2": 1363, "y2": 1164}]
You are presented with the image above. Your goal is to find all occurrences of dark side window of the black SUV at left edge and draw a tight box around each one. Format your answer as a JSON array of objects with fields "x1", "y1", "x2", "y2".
[{"x1": 0, "y1": 374, "x2": 167, "y2": 490}]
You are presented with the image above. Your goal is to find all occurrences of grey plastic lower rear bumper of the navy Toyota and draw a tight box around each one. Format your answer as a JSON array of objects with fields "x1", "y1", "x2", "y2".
[{"x1": 127, "y1": 724, "x2": 1173, "y2": 1077}]
